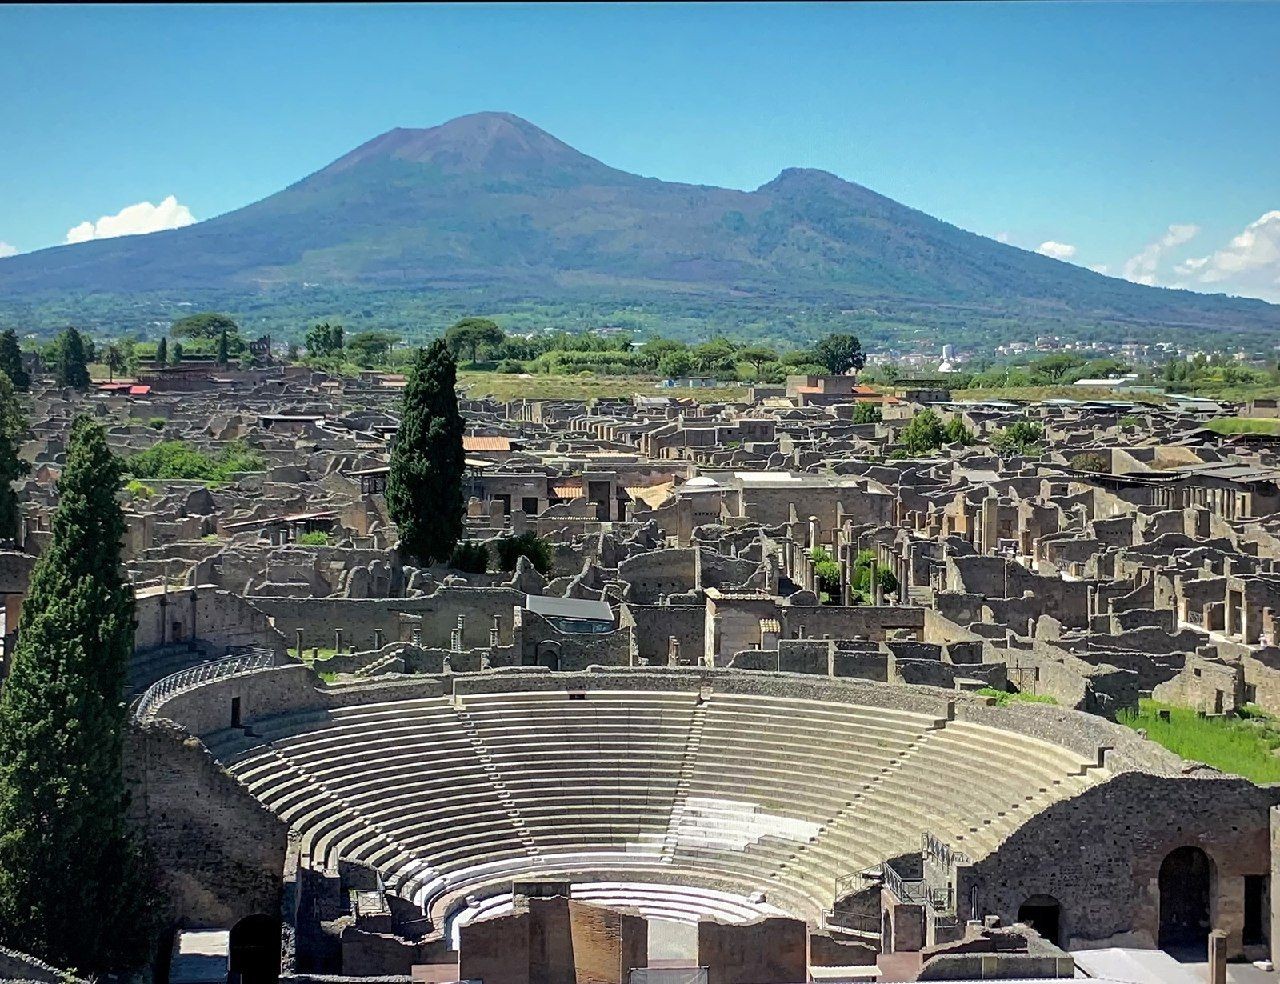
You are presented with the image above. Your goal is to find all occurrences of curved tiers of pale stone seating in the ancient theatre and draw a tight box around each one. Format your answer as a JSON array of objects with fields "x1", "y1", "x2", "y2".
[{"x1": 210, "y1": 691, "x2": 1107, "y2": 917}]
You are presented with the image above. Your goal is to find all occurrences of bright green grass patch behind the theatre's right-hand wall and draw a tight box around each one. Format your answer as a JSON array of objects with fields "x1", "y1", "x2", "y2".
[{"x1": 1117, "y1": 700, "x2": 1280, "y2": 782}]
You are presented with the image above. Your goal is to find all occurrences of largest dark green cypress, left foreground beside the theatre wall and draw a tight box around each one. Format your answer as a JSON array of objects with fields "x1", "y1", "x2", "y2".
[{"x1": 0, "y1": 417, "x2": 151, "y2": 972}]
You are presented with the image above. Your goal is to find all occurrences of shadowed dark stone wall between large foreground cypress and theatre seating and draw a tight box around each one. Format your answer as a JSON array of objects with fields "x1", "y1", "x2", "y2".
[{"x1": 124, "y1": 723, "x2": 288, "y2": 926}]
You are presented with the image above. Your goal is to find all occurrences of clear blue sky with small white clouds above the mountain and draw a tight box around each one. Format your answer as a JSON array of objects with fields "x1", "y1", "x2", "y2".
[{"x1": 0, "y1": 3, "x2": 1280, "y2": 301}]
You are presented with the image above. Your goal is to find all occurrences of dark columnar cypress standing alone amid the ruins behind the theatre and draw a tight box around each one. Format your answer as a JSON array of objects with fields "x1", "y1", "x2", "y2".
[{"x1": 387, "y1": 339, "x2": 466, "y2": 563}]
